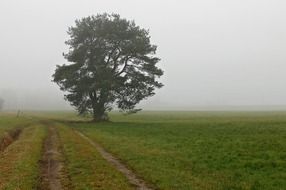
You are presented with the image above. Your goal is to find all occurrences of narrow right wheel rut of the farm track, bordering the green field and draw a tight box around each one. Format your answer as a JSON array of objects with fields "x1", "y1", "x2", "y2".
[{"x1": 75, "y1": 130, "x2": 152, "y2": 190}]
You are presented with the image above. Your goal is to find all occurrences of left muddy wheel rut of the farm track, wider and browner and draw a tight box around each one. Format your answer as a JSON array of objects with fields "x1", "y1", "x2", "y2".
[{"x1": 39, "y1": 126, "x2": 71, "y2": 190}]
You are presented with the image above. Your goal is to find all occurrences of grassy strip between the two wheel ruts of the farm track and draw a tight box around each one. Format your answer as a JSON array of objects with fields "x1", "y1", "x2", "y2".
[{"x1": 57, "y1": 124, "x2": 133, "y2": 190}]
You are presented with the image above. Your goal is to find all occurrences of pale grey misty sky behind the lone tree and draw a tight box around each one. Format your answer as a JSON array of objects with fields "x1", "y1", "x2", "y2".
[{"x1": 0, "y1": 0, "x2": 286, "y2": 109}]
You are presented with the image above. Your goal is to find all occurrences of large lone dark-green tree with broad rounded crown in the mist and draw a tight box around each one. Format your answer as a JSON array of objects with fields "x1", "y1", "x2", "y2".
[{"x1": 53, "y1": 13, "x2": 163, "y2": 121}]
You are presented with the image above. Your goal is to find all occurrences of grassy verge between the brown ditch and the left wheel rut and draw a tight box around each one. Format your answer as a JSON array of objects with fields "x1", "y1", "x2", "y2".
[{"x1": 0, "y1": 125, "x2": 46, "y2": 190}]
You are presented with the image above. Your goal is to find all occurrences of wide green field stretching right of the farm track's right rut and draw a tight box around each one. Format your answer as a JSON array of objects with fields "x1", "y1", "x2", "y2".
[{"x1": 74, "y1": 112, "x2": 286, "y2": 190}]
